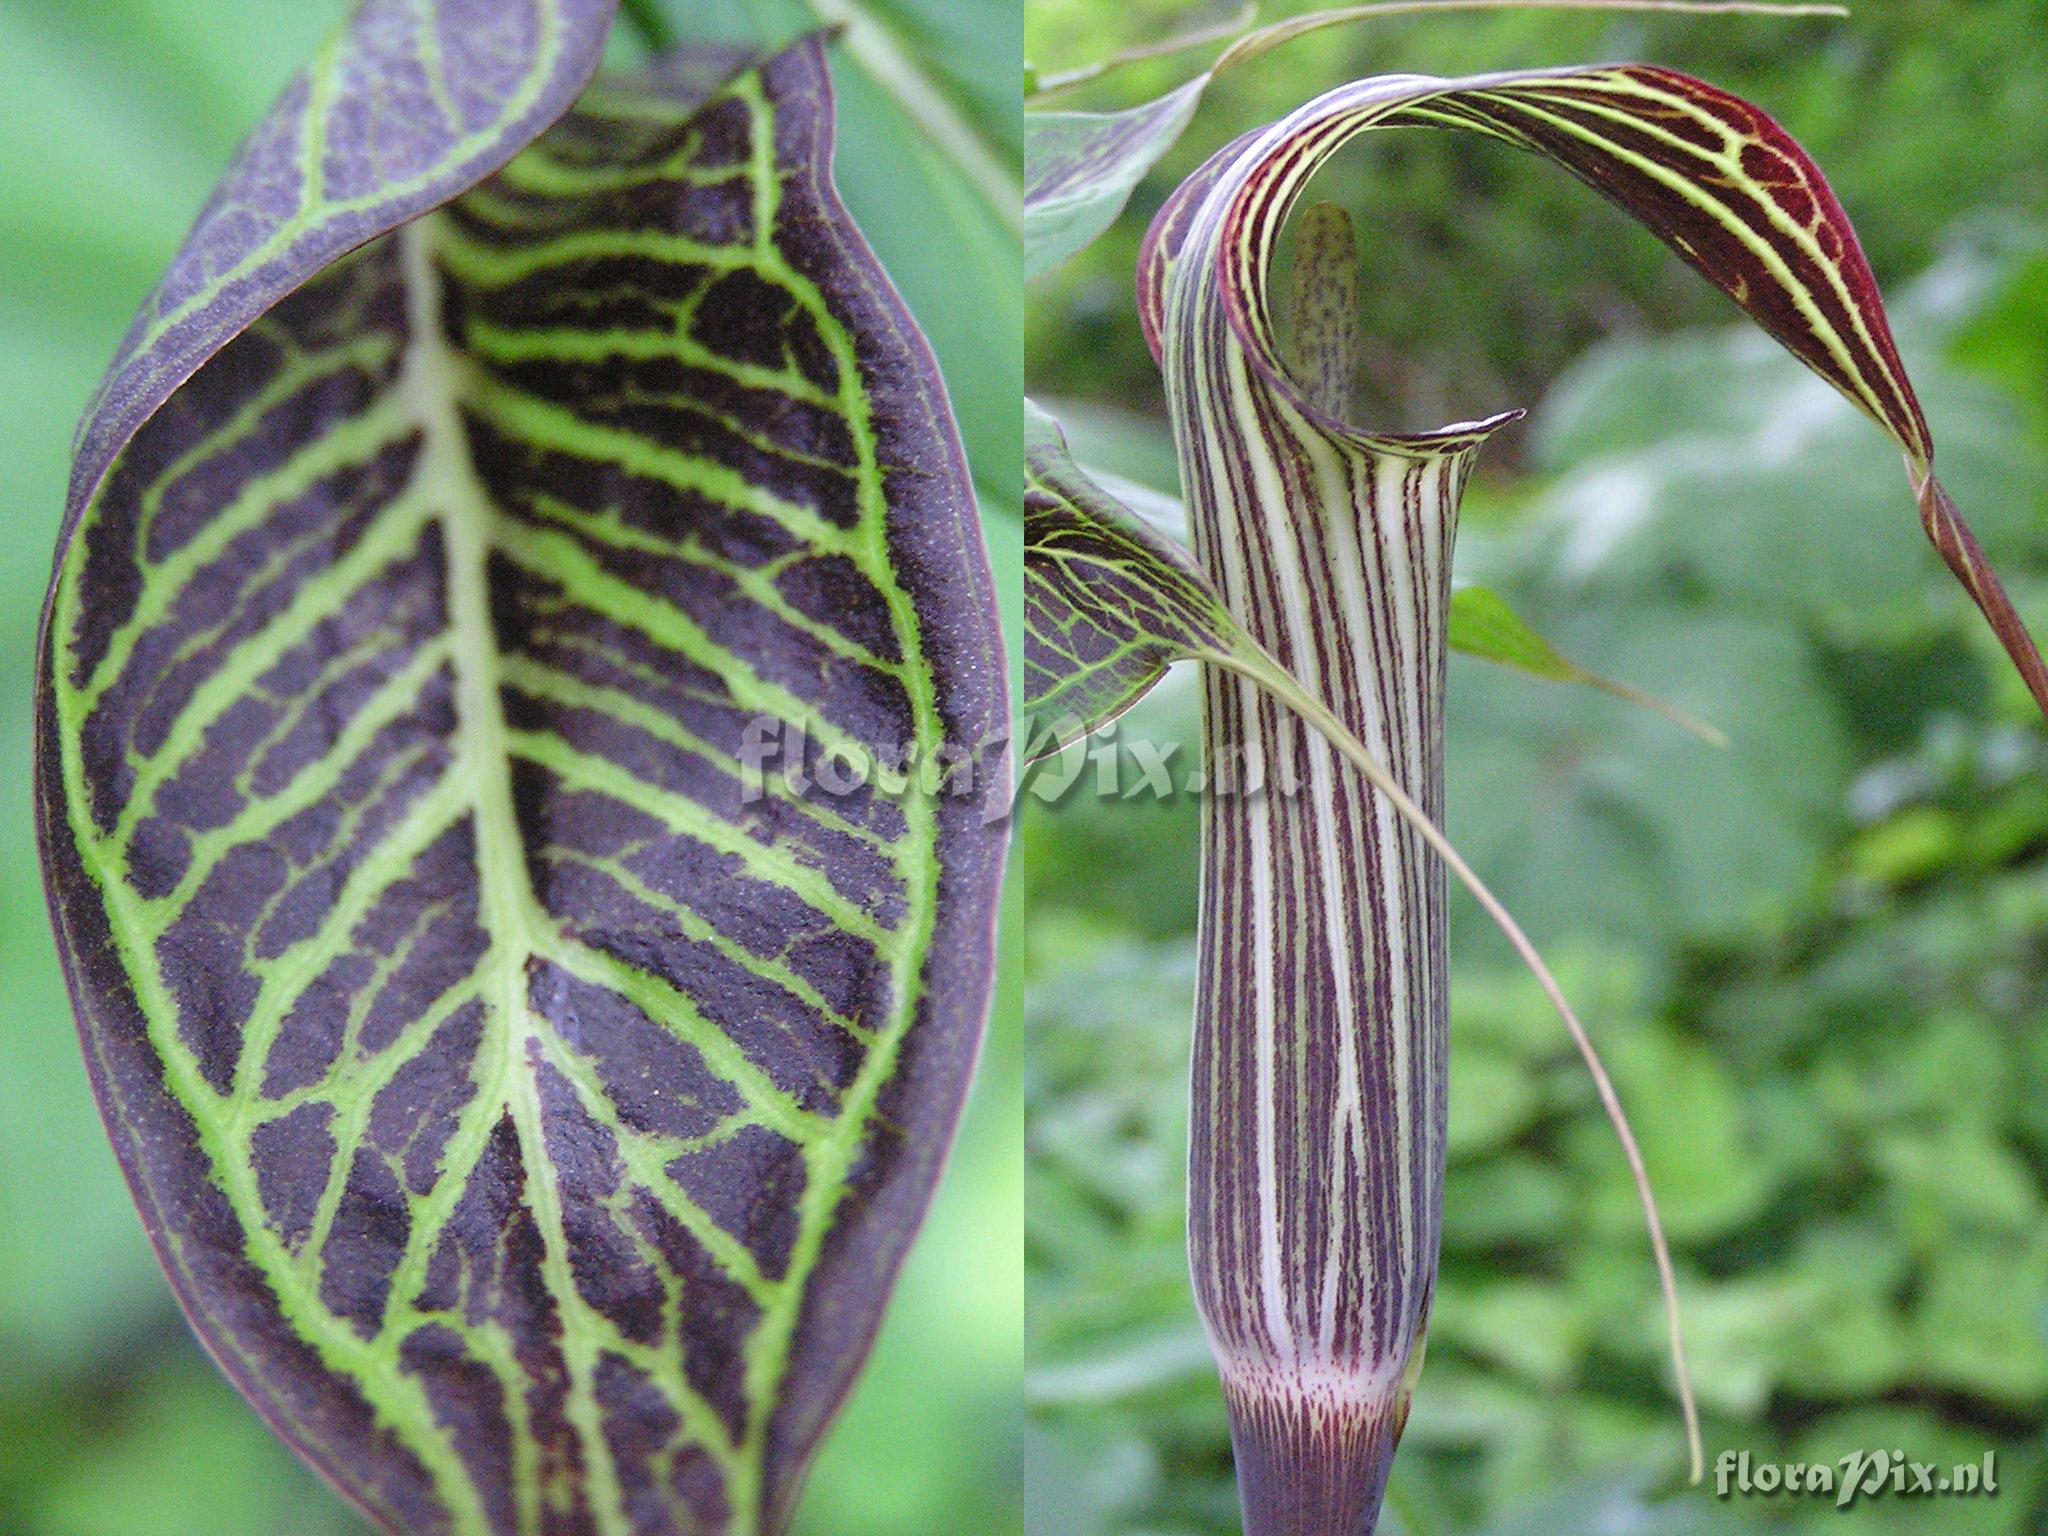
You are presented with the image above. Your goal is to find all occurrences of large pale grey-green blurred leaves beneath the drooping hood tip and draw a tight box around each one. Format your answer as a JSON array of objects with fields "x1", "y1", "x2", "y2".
[{"x1": 1450, "y1": 236, "x2": 2048, "y2": 952}]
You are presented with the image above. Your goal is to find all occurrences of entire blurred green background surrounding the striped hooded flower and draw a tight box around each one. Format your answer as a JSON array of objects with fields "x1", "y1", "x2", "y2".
[{"x1": 1022, "y1": 0, "x2": 2048, "y2": 1536}]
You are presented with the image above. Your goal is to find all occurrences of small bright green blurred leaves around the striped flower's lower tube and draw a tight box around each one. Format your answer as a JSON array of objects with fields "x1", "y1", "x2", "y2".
[{"x1": 1026, "y1": 716, "x2": 2048, "y2": 1536}]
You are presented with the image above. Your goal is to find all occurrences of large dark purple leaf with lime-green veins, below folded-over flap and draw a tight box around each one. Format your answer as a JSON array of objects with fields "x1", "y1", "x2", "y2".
[{"x1": 39, "y1": 24, "x2": 1008, "y2": 1536}]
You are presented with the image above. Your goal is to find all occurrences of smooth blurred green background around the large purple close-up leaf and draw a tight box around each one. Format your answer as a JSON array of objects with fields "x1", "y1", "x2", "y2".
[{"x1": 0, "y1": 0, "x2": 1022, "y2": 1536}]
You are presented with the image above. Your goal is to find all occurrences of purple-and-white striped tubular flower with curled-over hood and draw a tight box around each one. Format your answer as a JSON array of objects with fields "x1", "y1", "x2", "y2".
[{"x1": 1139, "y1": 54, "x2": 2048, "y2": 1536}]
